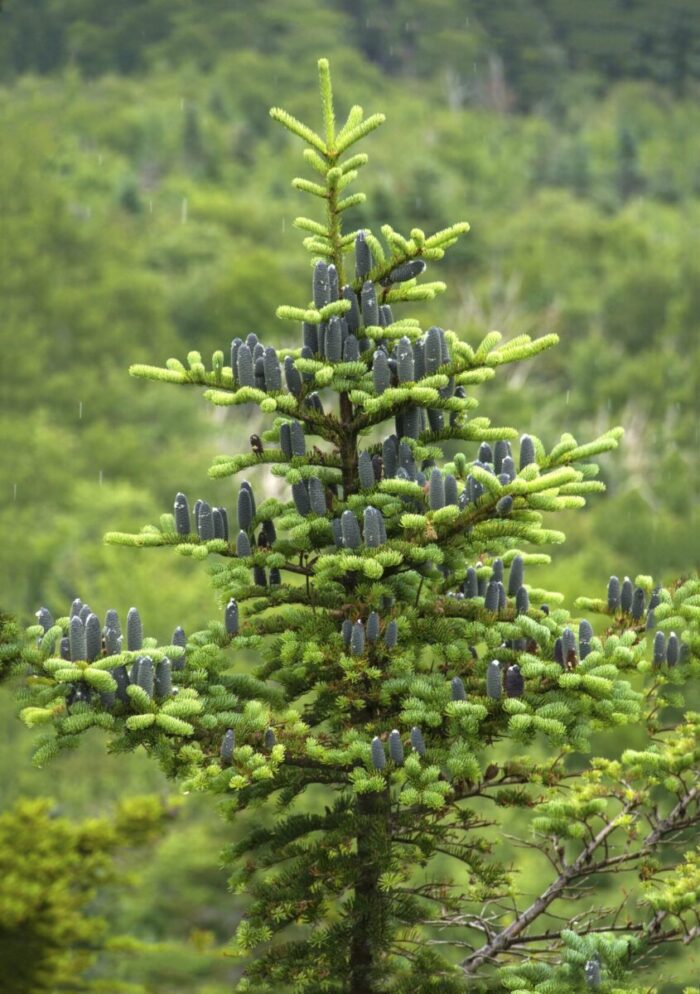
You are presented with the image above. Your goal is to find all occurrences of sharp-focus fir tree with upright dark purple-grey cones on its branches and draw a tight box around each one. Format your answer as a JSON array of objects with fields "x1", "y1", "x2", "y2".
[{"x1": 6, "y1": 60, "x2": 700, "y2": 994}]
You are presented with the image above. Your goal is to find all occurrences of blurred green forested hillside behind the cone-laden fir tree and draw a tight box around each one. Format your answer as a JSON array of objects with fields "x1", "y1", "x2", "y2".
[{"x1": 0, "y1": 0, "x2": 700, "y2": 994}]
